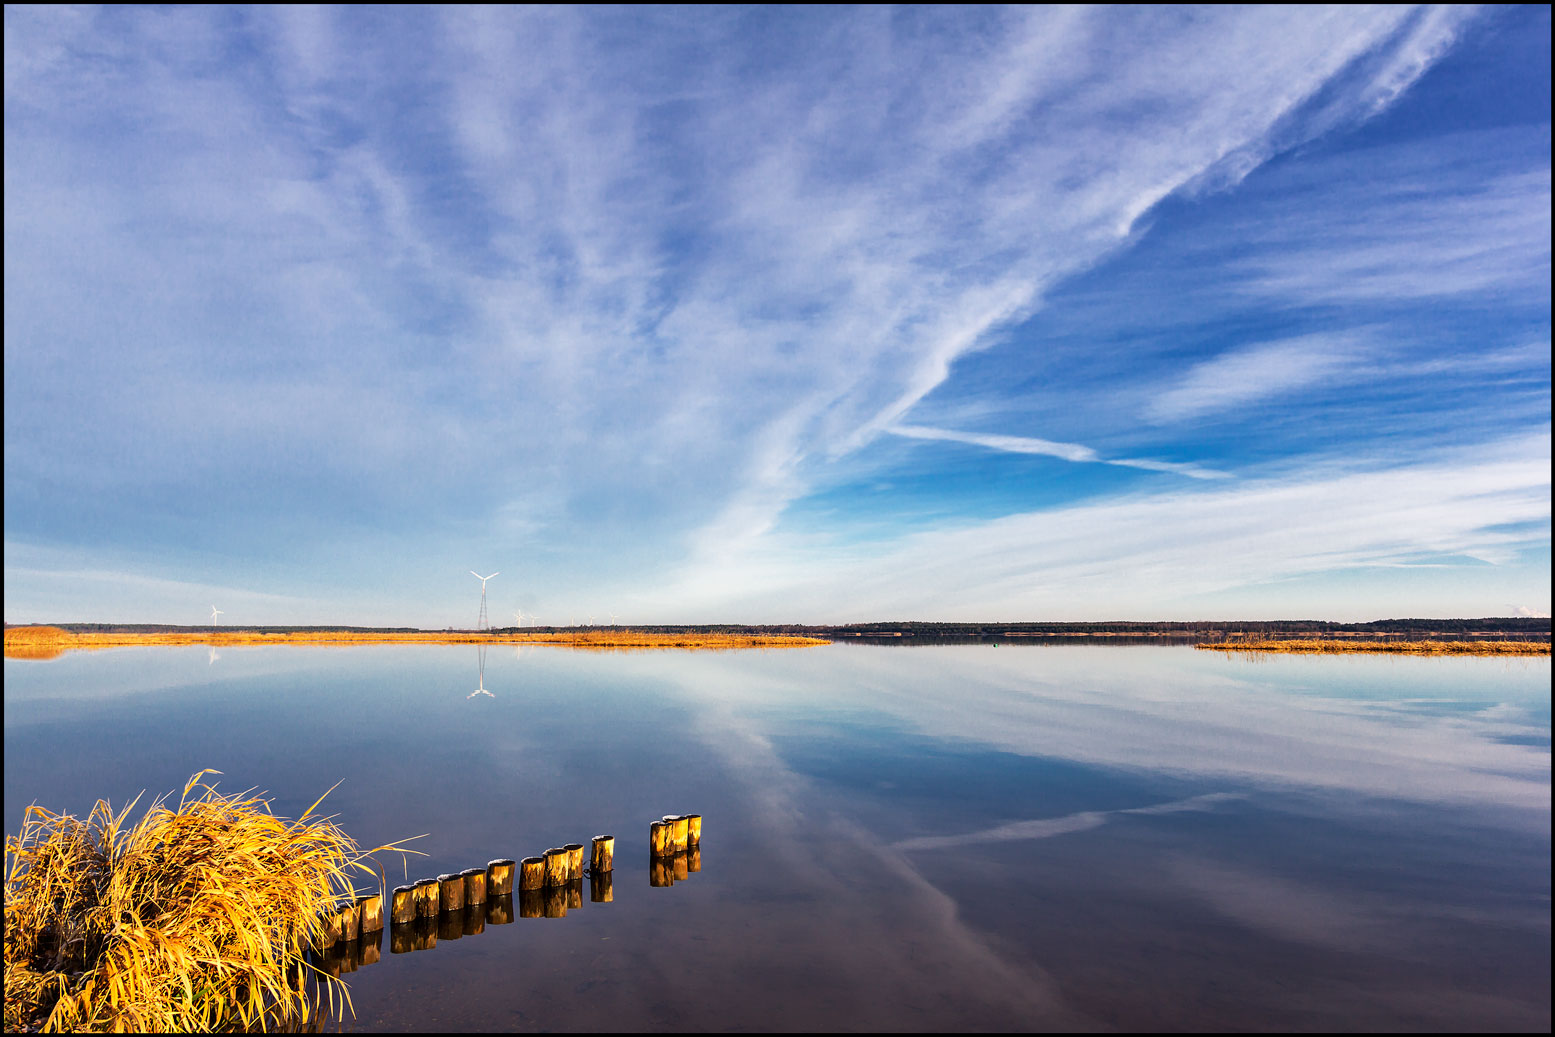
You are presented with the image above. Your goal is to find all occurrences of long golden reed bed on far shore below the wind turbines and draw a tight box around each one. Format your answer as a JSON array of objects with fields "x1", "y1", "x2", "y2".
[{"x1": 5, "y1": 627, "x2": 827, "y2": 659}]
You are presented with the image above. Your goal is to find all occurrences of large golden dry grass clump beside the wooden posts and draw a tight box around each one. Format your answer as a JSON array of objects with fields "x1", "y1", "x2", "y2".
[{"x1": 5, "y1": 771, "x2": 395, "y2": 1032}]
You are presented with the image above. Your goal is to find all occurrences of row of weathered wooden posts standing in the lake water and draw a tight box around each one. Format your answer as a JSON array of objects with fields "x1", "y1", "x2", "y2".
[{"x1": 317, "y1": 813, "x2": 701, "y2": 964}]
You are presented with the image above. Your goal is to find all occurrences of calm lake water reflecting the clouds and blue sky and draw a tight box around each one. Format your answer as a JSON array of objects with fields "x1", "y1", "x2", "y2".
[{"x1": 5, "y1": 645, "x2": 1550, "y2": 1031}]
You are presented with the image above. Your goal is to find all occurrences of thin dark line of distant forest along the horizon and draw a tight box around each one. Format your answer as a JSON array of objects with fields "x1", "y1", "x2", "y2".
[{"x1": 18, "y1": 616, "x2": 1550, "y2": 641}]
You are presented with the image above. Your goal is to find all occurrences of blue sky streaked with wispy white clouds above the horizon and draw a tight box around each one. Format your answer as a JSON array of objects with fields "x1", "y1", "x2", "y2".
[{"x1": 5, "y1": 6, "x2": 1550, "y2": 627}]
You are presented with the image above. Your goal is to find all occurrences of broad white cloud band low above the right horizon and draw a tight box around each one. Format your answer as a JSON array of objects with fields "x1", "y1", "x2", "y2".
[{"x1": 675, "y1": 431, "x2": 1550, "y2": 620}]
